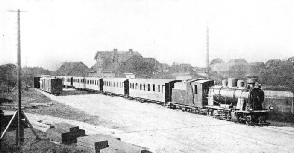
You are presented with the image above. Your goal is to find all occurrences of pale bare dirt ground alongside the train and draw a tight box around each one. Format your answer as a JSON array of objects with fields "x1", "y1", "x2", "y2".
[{"x1": 39, "y1": 88, "x2": 294, "y2": 153}]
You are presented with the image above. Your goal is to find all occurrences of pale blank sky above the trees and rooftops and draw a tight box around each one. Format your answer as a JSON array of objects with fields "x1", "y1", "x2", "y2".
[{"x1": 0, "y1": 0, "x2": 294, "y2": 70}]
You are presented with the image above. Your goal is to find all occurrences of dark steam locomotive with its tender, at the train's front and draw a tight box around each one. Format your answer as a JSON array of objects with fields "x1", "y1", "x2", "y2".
[{"x1": 168, "y1": 76, "x2": 273, "y2": 125}]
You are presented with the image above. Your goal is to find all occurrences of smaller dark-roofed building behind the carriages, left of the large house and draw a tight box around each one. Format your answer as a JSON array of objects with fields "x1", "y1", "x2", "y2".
[{"x1": 56, "y1": 62, "x2": 90, "y2": 76}]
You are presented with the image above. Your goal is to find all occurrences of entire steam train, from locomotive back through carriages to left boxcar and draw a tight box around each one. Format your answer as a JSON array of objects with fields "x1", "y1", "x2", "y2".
[{"x1": 35, "y1": 76, "x2": 272, "y2": 125}]
